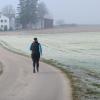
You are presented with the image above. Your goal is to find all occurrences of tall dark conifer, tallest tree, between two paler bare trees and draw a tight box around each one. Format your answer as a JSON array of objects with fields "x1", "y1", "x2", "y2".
[{"x1": 18, "y1": 0, "x2": 38, "y2": 28}]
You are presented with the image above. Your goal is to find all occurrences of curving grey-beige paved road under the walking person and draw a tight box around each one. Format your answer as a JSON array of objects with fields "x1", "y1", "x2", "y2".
[{"x1": 0, "y1": 47, "x2": 72, "y2": 100}]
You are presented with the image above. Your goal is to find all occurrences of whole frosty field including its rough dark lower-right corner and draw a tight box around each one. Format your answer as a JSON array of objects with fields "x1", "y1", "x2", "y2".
[{"x1": 0, "y1": 32, "x2": 100, "y2": 100}]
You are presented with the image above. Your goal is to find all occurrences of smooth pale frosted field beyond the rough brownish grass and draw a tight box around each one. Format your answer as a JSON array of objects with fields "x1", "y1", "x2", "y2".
[{"x1": 0, "y1": 33, "x2": 100, "y2": 72}]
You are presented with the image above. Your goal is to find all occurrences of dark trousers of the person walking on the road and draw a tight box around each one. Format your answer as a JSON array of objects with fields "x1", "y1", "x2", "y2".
[{"x1": 32, "y1": 54, "x2": 40, "y2": 73}]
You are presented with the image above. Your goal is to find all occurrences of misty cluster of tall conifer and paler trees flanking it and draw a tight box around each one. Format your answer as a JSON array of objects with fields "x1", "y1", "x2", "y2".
[{"x1": 2, "y1": 0, "x2": 49, "y2": 28}]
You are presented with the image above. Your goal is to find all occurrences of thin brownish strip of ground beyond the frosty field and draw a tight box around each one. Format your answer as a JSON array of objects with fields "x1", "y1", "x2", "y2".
[{"x1": 0, "y1": 25, "x2": 100, "y2": 35}]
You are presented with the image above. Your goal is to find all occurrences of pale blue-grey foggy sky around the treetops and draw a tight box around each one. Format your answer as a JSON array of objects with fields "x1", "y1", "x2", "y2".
[{"x1": 0, "y1": 0, "x2": 100, "y2": 24}]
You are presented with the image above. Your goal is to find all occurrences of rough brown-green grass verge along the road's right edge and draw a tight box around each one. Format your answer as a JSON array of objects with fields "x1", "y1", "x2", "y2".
[{"x1": 43, "y1": 59, "x2": 100, "y2": 100}]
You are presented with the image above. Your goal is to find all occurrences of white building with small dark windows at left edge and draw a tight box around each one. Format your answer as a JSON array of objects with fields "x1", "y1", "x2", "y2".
[{"x1": 0, "y1": 14, "x2": 10, "y2": 31}]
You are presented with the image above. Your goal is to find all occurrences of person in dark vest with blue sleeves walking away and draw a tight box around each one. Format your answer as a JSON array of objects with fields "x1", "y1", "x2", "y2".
[{"x1": 30, "y1": 38, "x2": 42, "y2": 73}]
